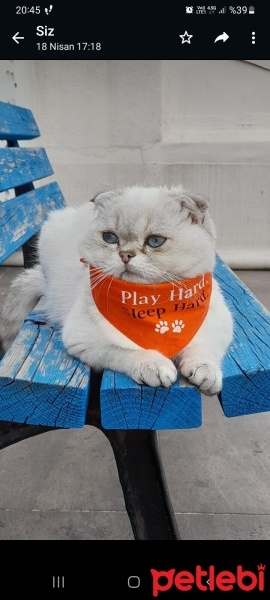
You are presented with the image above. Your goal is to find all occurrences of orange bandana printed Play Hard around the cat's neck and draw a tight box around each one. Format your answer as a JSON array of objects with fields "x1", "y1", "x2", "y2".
[{"x1": 89, "y1": 266, "x2": 212, "y2": 358}]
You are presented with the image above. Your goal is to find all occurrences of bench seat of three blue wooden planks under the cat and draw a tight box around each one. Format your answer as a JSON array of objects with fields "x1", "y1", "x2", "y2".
[{"x1": 0, "y1": 257, "x2": 270, "y2": 430}]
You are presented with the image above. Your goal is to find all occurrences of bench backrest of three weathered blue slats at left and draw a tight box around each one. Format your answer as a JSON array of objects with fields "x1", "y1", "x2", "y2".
[{"x1": 0, "y1": 102, "x2": 65, "y2": 264}]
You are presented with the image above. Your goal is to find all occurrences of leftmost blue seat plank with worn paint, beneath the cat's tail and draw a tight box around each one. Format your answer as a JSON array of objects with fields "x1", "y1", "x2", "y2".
[{"x1": 0, "y1": 312, "x2": 90, "y2": 428}]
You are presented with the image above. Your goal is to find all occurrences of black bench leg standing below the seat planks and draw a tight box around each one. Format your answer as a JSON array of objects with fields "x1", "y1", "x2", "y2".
[{"x1": 102, "y1": 429, "x2": 180, "y2": 540}]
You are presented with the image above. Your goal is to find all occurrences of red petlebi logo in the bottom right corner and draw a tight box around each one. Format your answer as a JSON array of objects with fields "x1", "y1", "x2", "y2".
[{"x1": 150, "y1": 563, "x2": 266, "y2": 598}]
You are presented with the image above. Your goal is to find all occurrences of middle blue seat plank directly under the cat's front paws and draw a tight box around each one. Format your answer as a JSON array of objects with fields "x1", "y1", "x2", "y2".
[{"x1": 100, "y1": 370, "x2": 202, "y2": 430}]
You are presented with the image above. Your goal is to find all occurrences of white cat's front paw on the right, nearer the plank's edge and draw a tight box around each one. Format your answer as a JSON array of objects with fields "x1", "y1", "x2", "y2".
[{"x1": 179, "y1": 358, "x2": 222, "y2": 396}]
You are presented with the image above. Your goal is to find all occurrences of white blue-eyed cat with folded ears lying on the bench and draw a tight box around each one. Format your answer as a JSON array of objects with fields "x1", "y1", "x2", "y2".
[{"x1": 1, "y1": 186, "x2": 233, "y2": 395}]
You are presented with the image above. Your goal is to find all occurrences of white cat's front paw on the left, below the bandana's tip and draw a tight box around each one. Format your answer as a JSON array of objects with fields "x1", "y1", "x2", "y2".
[{"x1": 132, "y1": 350, "x2": 177, "y2": 387}]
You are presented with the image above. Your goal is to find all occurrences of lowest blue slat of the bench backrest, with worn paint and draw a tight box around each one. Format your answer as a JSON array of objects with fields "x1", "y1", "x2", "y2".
[{"x1": 0, "y1": 183, "x2": 65, "y2": 264}]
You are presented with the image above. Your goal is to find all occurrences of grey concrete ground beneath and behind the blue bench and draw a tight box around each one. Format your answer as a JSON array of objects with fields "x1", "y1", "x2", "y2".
[{"x1": 0, "y1": 267, "x2": 270, "y2": 540}]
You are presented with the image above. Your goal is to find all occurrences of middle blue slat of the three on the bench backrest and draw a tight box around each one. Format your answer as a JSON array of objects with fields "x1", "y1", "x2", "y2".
[{"x1": 0, "y1": 148, "x2": 53, "y2": 192}]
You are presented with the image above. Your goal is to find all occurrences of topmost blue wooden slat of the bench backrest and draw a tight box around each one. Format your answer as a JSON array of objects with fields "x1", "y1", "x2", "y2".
[{"x1": 0, "y1": 102, "x2": 40, "y2": 140}]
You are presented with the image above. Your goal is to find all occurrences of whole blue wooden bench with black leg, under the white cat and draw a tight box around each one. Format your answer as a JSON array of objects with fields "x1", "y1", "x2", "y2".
[{"x1": 0, "y1": 102, "x2": 270, "y2": 540}]
